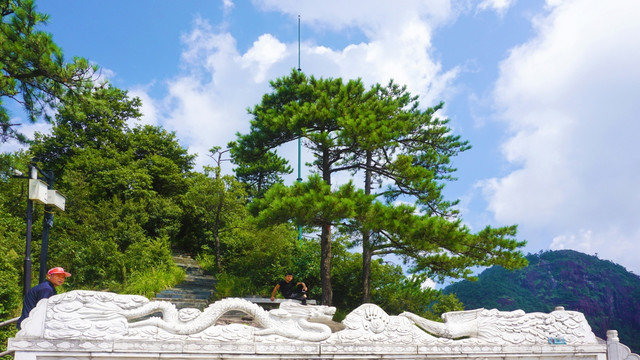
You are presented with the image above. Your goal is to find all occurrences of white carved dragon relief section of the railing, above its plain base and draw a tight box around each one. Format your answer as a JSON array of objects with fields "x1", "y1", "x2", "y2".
[{"x1": 16, "y1": 291, "x2": 597, "y2": 348}]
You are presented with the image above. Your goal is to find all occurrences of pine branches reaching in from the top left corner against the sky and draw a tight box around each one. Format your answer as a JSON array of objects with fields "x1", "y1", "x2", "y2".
[{"x1": 0, "y1": 0, "x2": 97, "y2": 142}]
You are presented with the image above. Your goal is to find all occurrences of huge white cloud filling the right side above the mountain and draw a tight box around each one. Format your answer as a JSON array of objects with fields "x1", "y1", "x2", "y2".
[{"x1": 482, "y1": 0, "x2": 640, "y2": 271}]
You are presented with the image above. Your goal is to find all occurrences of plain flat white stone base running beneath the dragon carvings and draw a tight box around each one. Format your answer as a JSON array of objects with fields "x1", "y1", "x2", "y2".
[{"x1": 9, "y1": 339, "x2": 607, "y2": 360}]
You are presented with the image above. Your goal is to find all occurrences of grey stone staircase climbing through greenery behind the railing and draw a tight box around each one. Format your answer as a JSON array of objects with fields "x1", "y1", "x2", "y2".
[{"x1": 153, "y1": 253, "x2": 217, "y2": 310}]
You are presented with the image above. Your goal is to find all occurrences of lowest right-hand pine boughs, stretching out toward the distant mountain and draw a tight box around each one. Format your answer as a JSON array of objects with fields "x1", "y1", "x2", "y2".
[{"x1": 350, "y1": 202, "x2": 526, "y2": 286}]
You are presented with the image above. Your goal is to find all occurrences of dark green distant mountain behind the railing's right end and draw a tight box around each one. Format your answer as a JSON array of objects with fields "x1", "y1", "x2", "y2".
[{"x1": 443, "y1": 250, "x2": 640, "y2": 353}]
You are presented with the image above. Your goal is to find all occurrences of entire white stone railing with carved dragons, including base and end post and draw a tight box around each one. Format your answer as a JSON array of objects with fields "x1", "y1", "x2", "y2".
[{"x1": 8, "y1": 291, "x2": 640, "y2": 360}]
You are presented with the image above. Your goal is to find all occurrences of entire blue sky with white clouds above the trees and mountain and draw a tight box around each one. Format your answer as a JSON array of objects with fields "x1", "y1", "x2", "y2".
[{"x1": 2, "y1": 0, "x2": 640, "y2": 274}]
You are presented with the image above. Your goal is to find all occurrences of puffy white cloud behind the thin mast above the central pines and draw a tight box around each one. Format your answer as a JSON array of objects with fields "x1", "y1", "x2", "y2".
[{"x1": 137, "y1": 1, "x2": 458, "y2": 172}]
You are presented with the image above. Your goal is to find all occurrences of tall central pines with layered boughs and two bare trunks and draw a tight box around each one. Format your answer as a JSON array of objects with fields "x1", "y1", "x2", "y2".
[{"x1": 236, "y1": 70, "x2": 525, "y2": 304}]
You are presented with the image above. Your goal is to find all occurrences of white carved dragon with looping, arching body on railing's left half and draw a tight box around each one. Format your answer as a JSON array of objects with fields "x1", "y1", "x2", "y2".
[{"x1": 23, "y1": 290, "x2": 335, "y2": 341}]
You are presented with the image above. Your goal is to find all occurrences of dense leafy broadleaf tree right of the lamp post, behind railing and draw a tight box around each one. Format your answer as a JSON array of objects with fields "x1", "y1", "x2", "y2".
[{"x1": 23, "y1": 87, "x2": 193, "y2": 295}]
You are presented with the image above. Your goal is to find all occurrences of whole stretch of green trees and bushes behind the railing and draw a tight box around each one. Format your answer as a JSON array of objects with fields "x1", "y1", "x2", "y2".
[{"x1": 0, "y1": 0, "x2": 527, "y2": 354}]
